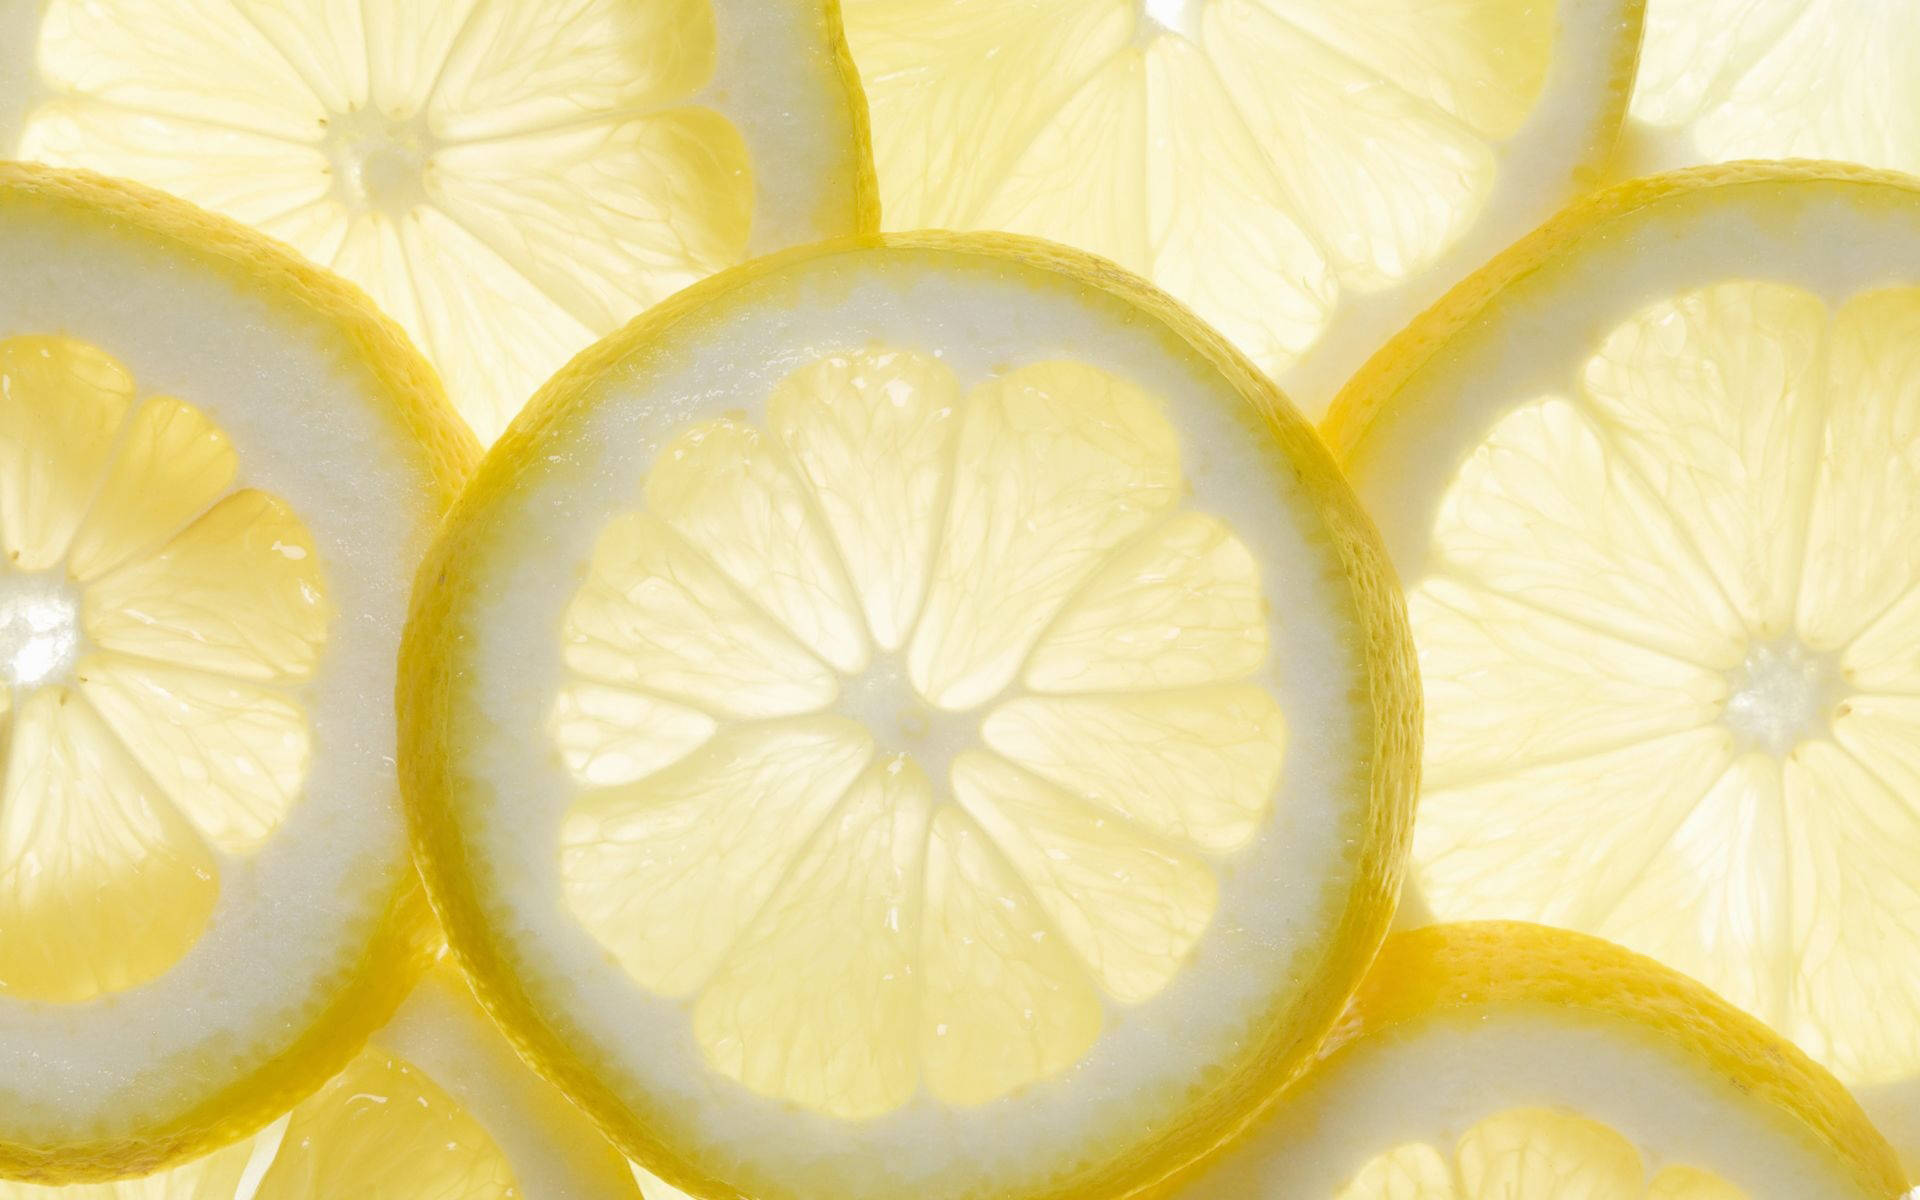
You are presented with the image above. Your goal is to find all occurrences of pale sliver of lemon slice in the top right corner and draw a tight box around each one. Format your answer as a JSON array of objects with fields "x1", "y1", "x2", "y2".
[{"x1": 1615, "y1": 0, "x2": 1920, "y2": 175}]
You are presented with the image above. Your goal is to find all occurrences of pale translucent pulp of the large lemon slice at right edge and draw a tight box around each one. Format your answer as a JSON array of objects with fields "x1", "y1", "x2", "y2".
[{"x1": 1411, "y1": 280, "x2": 1920, "y2": 1083}]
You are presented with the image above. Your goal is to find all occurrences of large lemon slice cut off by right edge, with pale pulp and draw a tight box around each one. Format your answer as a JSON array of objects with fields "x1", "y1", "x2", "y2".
[{"x1": 1327, "y1": 165, "x2": 1920, "y2": 1175}]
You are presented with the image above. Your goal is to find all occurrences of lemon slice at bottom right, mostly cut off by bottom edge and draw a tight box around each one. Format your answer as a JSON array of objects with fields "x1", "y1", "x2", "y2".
[{"x1": 1181, "y1": 922, "x2": 1905, "y2": 1200}]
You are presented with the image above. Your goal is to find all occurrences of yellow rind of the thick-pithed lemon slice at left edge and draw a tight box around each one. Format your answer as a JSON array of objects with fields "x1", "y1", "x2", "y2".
[{"x1": 0, "y1": 163, "x2": 480, "y2": 1185}]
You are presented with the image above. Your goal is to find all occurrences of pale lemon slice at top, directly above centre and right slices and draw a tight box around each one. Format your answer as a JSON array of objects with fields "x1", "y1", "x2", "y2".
[{"x1": 843, "y1": 0, "x2": 1640, "y2": 415}]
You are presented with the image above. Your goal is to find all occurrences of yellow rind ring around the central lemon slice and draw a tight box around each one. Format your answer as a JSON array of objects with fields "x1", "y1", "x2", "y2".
[{"x1": 399, "y1": 232, "x2": 1423, "y2": 1200}]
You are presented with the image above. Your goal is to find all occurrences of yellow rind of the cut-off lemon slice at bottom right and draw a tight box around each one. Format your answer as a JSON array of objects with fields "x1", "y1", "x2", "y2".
[{"x1": 1319, "y1": 922, "x2": 1907, "y2": 1200}]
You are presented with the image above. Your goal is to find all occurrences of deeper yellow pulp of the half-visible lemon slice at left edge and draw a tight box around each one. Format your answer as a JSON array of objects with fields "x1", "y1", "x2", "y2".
[{"x1": 0, "y1": 336, "x2": 328, "y2": 1002}]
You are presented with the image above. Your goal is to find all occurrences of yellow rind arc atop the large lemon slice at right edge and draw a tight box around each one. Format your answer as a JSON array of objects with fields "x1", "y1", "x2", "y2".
[{"x1": 1321, "y1": 159, "x2": 1920, "y2": 463}]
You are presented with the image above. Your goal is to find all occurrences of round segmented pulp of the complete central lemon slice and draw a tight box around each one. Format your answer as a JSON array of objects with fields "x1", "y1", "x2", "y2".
[{"x1": 551, "y1": 348, "x2": 1286, "y2": 1119}]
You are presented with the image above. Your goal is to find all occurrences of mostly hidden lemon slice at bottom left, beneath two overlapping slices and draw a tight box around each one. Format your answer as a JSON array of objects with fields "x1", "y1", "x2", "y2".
[{"x1": 0, "y1": 968, "x2": 639, "y2": 1200}]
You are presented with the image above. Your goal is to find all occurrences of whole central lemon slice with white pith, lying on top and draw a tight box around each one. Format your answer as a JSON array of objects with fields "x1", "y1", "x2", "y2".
[{"x1": 401, "y1": 234, "x2": 1417, "y2": 1200}]
